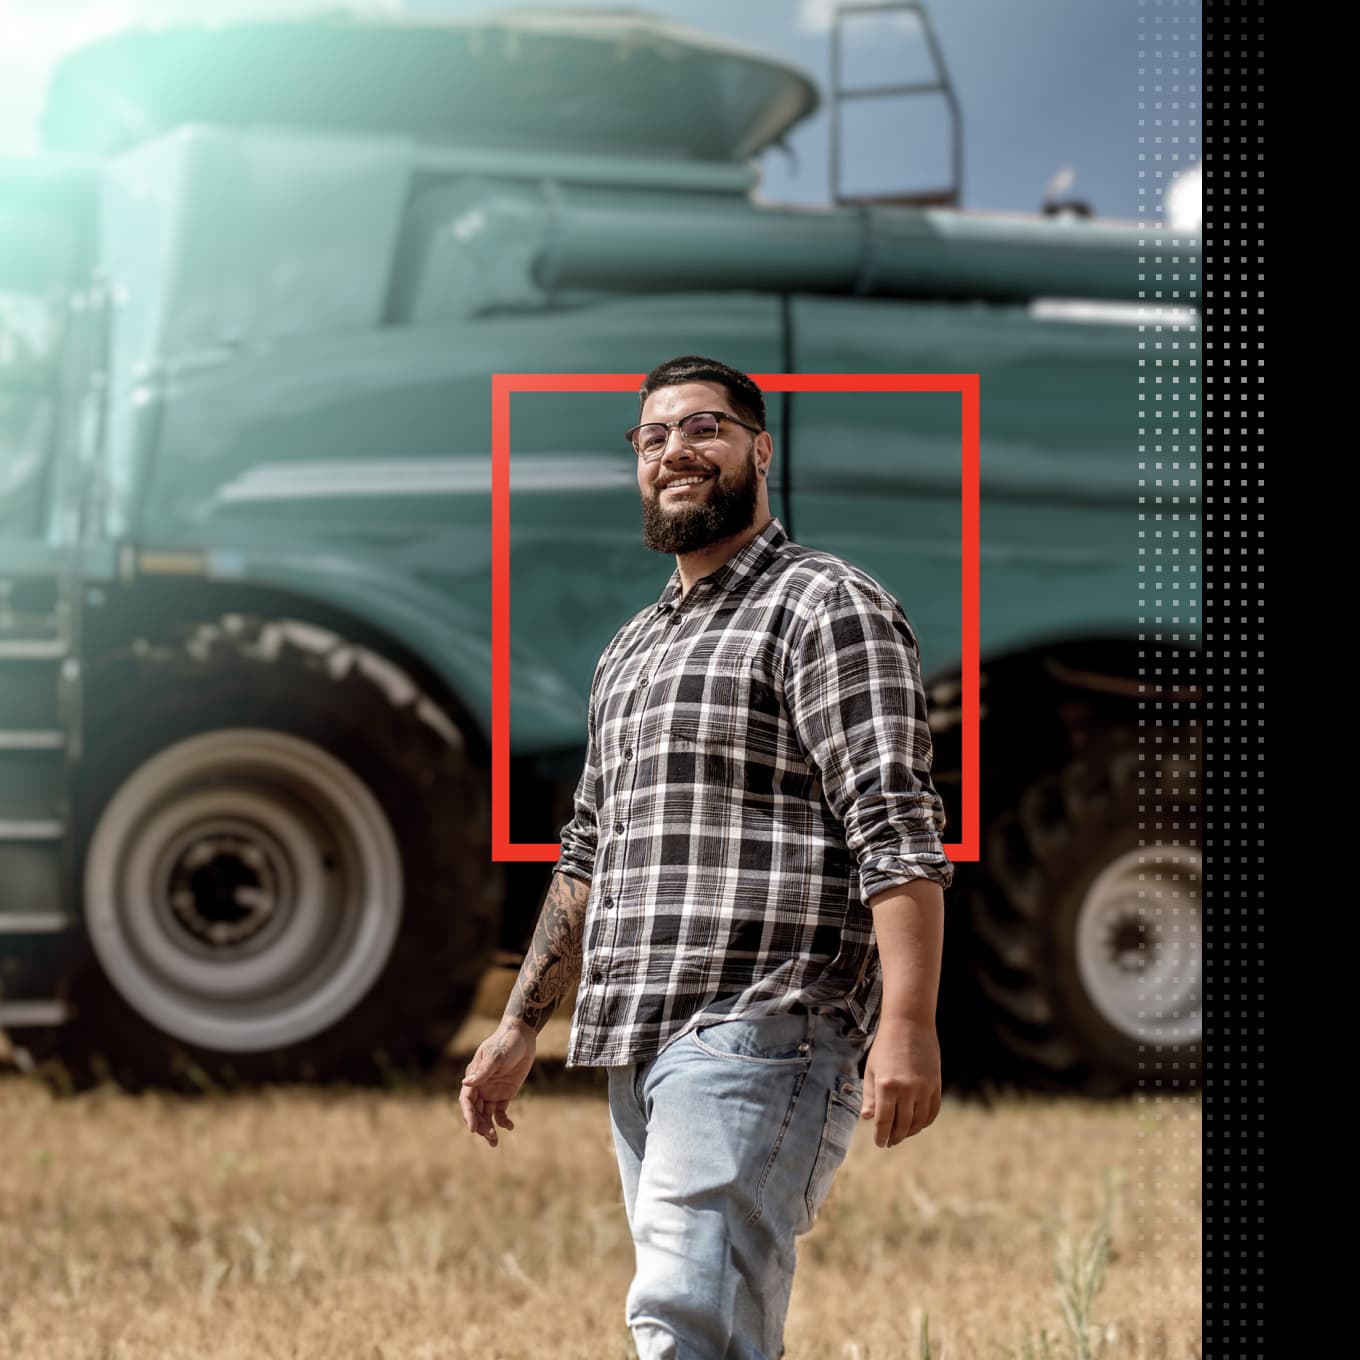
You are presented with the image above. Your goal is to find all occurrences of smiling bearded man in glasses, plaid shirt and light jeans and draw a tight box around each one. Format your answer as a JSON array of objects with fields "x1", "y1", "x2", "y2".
[{"x1": 460, "y1": 355, "x2": 953, "y2": 1360}]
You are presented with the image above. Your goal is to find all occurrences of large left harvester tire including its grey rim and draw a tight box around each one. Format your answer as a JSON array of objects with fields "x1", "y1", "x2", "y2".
[{"x1": 60, "y1": 615, "x2": 503, "y2": 1088}]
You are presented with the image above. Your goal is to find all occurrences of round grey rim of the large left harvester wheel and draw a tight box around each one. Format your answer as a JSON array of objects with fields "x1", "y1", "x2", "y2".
[{"x1": 84, "y1": 728, "x2": 403, "y2": 1053}]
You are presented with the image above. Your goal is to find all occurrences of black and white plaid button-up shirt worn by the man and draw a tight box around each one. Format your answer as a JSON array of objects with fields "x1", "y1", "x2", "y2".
[{"x1": 556, "y1": 520, "x2": 953, "y2": 1066}]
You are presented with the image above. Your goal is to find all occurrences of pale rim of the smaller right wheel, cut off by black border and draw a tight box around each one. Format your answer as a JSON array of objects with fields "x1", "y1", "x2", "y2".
[{"x1": 1077, "y1": 846, "x2": 1204, "y2": 1044}]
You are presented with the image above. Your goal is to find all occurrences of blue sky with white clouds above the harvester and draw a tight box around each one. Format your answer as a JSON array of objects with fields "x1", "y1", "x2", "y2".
[{"x1": 0, "y1": 0, "x2": 1200, "y2": 219}]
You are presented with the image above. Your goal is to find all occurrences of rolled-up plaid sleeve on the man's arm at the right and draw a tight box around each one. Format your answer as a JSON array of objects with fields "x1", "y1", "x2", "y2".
[{"x1": 785, "y1": 578, "x2": 953, "y2": 904}]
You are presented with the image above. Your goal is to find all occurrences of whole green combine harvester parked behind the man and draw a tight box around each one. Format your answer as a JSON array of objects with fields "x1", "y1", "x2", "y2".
[{"x1": 0, "y1": 10, "x2": 1201, "y2": 1091}]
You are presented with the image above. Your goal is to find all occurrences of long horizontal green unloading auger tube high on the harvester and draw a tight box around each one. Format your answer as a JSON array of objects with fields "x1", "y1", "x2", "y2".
[{"x1": 391, "y1": 175, "x2": 1169, "y2": 321}]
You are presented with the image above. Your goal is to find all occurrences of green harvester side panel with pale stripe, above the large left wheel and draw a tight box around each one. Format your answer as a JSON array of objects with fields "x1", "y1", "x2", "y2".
[{"x1": 135, "y1": 294, "x2": 782, "y2": 751}]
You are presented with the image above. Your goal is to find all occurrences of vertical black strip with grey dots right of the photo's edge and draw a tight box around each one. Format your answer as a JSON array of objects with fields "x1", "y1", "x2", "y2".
[{"x1": 1202, "y1": 0, "x2": 1265, "y2": 1357}]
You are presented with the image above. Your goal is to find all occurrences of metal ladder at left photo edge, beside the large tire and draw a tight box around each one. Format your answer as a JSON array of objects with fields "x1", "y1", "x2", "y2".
[{"x1": 0, "y1": 541, "x2": 80, "y2": 1044}]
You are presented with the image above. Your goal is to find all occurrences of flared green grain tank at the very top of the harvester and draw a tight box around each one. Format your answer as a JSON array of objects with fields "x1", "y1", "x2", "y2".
[{"x1": 44, "y1": 11, "x2": 817, "y2": 160}]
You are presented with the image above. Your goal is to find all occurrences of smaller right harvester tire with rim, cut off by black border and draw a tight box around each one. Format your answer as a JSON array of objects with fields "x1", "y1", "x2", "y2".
[{"x1": 970, "y1": 732, "x2": 1204, "y2": 1095}]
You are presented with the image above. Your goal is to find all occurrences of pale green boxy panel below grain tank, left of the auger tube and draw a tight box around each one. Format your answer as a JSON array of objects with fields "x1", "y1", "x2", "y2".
[{"x1": 102, "y1": 128, "x2": 408, "y2": 536}]
